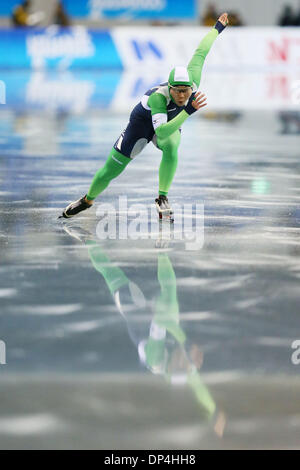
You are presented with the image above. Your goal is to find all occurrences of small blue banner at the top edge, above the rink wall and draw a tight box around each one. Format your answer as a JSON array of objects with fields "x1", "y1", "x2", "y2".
[{"x1": 63, "y1": 0, "x2": 197, "y2": 21}]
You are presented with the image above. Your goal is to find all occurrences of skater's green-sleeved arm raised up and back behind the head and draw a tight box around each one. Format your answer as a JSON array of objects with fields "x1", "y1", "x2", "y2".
[{"x1": 188, "y1": 13, "x2": 228, "y2": 88}]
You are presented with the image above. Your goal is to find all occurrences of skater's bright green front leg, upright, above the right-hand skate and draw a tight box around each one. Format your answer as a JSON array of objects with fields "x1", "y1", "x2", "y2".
[{"x1": 157, "y1": 131, "x2": 180, "y2": 196}]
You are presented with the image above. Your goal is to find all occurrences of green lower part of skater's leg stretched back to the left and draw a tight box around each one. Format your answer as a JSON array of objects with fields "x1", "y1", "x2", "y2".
[{"x1": 86, "y1": 148, "x2": 131, "y2": 201}]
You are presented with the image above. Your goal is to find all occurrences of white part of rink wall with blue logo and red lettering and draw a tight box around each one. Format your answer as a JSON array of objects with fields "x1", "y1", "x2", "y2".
[{"x1": 111, "y1": 27, "x2": 300, "y2": 72}]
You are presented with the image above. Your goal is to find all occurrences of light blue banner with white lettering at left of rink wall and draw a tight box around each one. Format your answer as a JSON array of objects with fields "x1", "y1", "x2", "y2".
[{"x1": 0, "y1": 26, "x2": 122, "y2": 70}]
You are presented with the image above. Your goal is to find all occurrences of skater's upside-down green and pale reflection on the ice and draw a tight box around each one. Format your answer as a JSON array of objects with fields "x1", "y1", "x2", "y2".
[{"x1": 64, "y1": 226, "x2": 225, "y2": 437}]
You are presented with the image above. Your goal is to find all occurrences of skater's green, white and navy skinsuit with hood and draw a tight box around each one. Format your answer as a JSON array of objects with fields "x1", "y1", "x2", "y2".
[{"x1": 87, "y1": 21, "x2": 224, "y2": 201}]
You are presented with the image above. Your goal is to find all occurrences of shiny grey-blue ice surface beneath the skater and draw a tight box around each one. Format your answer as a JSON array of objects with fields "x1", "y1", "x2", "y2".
[{"x1": 0, "y1": 102, "x2": 300, "y2": 449}]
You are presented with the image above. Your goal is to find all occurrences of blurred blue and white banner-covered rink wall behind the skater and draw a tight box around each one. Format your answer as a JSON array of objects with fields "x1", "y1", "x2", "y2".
[{"x1": 0, "y1": 26, "x2": 300, "y2": 70}]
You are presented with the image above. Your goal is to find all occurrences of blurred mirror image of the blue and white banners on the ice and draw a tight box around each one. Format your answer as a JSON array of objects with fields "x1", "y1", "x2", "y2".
[{"x1": 1, "y1": 69, "x2": 299, "y2": 112}]
